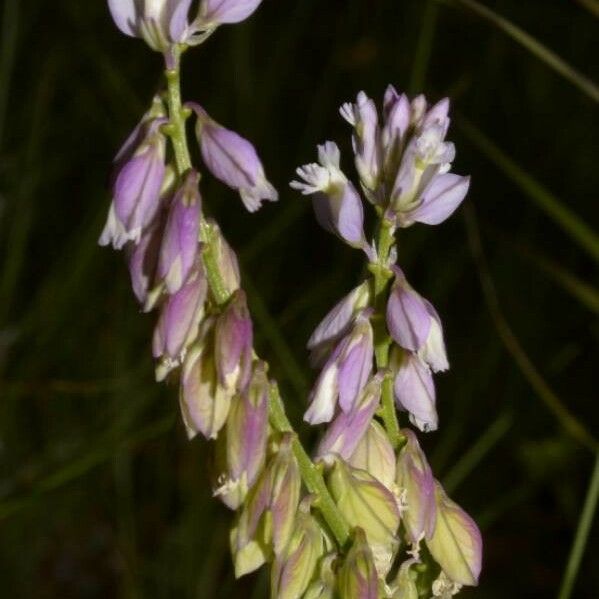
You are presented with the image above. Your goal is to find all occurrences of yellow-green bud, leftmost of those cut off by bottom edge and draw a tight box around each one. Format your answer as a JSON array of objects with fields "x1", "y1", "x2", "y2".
[{"x1": 271, "y1": 496, "x2": 324, "y2": 599}]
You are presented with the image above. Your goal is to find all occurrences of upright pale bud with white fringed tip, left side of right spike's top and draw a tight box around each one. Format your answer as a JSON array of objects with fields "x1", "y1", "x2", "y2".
[{"x1": 340, "y1": 92, "x2": 381, "y2": 191}]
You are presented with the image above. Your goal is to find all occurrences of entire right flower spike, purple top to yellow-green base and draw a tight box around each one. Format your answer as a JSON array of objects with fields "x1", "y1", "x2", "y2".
[{"x1": 291, "y1": 86, "x2": 482, "y2": 597}]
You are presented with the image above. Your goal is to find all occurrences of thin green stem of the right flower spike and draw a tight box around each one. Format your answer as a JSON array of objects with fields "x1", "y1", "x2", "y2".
[{"x1": 371, "y1": 217, "x2": 402, "y2": 449}]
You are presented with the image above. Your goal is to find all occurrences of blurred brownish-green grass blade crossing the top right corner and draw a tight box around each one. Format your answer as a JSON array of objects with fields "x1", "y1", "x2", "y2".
[{"x1": 443, "y1": 0, "x2": 599, "y2": 102}]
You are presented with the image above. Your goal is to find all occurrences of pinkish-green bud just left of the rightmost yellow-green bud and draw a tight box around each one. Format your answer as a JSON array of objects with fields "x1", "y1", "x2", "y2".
[{"x1": 397, "y1": 429, "x2": 436, "y2": 545}]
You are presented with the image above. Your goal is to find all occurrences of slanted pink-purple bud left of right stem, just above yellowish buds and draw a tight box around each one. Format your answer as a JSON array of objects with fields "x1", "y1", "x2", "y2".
[{"x1": 316, "y1": 373, "x2": 384, "y2": 461}]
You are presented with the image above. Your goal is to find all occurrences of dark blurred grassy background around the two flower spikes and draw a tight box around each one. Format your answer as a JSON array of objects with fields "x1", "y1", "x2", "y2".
[{"x1": 0, "y1": 0, "x2": 599, "y2": 599}]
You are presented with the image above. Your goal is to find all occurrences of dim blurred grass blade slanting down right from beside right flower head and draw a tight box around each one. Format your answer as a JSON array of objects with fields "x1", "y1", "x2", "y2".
[{"x1": 458, "y1": 117, "x2": 599, "y2": 262}]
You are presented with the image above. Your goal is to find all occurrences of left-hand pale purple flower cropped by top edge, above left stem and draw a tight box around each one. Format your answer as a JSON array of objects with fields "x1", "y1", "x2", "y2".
[{"x1": 108, "y1": 0, "x2": 192, "y2": 52}]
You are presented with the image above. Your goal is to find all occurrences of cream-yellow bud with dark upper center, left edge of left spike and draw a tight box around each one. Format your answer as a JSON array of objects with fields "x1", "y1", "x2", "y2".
[{"x1": 179, "y1": 320, "x2": 234, "y2": 439}]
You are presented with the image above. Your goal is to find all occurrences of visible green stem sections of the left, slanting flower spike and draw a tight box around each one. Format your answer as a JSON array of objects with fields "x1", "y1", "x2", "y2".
[{"x1": 165, "y1": 47, "x2": 350, "y2": 547}]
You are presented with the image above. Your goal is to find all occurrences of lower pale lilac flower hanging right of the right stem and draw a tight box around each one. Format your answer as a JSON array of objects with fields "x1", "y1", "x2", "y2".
[{"x1": 394, "y1": 352, "x2": 439, "y2": 432}]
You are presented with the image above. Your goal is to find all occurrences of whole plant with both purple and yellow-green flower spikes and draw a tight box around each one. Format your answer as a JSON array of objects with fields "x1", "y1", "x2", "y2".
[{"x1": 100, "y1": 0, "x2": 482, "y2": 599}]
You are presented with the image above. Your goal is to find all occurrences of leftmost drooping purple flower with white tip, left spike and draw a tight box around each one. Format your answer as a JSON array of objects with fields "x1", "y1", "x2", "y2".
[{"x1": 99, "y1": 118, "x2": 166, "y2": 250}]
